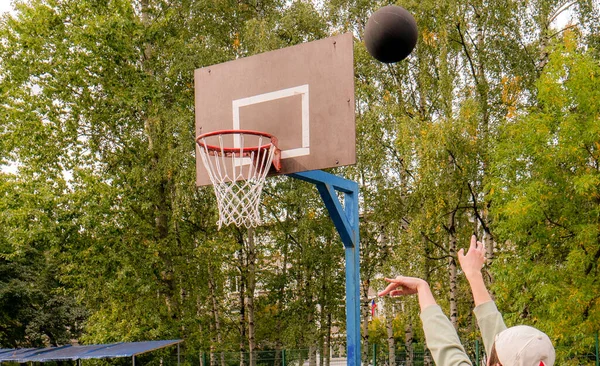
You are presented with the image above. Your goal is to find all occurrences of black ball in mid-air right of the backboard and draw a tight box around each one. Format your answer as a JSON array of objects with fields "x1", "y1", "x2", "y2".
[{"x1": 365, "y1": 5, "x2": 418, "y2": 63}]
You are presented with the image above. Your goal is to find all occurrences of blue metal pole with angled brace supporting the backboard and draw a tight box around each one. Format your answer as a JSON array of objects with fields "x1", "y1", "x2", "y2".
[{"x1": 289, "y1": 170, "x2": 361, "y2": 366}]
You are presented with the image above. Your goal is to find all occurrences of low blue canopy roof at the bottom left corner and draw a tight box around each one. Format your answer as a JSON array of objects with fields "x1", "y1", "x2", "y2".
[{"x1": 0, "y1": 339, "x2": 183, "y2": 363}]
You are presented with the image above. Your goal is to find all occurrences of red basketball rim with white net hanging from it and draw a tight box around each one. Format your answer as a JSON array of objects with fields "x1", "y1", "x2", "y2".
[{"x1": 196, "y1": 130, "x2": 281, "y2": 229}]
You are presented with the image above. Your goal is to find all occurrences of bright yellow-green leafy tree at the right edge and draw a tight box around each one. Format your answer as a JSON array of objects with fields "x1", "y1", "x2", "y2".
[{"x1": 491, "y1": 31, "x2": 600, "y2": 362}]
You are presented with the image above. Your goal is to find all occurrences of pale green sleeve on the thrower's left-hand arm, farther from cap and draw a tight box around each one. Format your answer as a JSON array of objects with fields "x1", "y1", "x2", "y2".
[{"x1": 421, "y1": 305, "x2": 472, "y2": 366}]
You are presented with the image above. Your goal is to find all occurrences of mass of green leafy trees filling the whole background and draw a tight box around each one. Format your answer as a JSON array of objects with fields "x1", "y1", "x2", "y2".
[{"x1": 0, "y1": 0, "x2": 600, "y2": 364}]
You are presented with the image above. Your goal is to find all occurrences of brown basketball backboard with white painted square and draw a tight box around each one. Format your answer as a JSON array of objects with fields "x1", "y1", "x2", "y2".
[{"x1": 194, "y1": 33, "x2": 356, "y2": 186}]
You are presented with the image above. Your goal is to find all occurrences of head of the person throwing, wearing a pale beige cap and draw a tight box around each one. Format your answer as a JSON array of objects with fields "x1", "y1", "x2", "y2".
[{"x1": 487, "y1": 325, "x2": 556, "y2": 366}]
